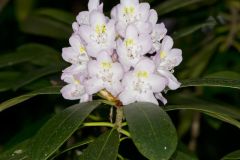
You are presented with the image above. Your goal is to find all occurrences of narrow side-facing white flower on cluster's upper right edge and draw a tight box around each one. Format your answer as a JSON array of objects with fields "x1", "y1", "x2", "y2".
[{"x1": 149, "y1": 9, "x2": 167, "y2": 53}]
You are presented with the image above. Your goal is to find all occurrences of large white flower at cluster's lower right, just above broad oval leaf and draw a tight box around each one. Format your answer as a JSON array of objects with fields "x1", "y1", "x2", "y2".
[{"x1": 119, "y1": 58, "x2": 166, "y2": 105}]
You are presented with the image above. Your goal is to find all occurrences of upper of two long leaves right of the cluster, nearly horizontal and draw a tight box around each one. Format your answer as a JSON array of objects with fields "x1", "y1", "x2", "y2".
[{"x1": 181, "y1": 78, "x2": 240, "y2": 89}]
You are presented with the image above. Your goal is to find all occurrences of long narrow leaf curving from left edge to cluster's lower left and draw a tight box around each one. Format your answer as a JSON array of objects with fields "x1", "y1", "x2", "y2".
[{"x1": 0, "y1": 86, "x2": 61, "y2": 112}]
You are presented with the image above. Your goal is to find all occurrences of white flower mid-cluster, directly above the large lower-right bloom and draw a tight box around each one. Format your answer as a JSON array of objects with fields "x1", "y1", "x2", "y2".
[{"x1": 117, "y1": 25, "x2": 152, "y2": 71}]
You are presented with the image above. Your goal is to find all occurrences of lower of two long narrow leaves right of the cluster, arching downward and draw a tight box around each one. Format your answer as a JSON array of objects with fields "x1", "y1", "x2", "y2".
[{"x1": 165, "y1": 104, "x2": 240, "y2": 128}]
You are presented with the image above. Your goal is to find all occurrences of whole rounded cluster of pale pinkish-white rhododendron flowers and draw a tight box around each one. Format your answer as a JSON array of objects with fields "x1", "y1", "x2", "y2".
[{"x1": 61, "y1": 0, "x2": 182, "y2": 105}]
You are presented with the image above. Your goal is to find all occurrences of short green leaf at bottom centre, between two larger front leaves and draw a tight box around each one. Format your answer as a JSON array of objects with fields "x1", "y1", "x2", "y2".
[{"x1": 80, "y1": 129, "x2": 120, "y2": 160}]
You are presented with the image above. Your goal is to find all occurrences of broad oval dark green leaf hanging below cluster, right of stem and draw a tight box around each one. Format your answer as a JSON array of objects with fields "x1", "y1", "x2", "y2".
[{"x1": 124, "y1": 103, "x2": 177, "y2": 160}]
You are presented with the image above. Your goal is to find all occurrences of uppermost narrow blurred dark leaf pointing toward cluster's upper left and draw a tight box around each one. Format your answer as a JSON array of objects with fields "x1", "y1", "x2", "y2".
[{"x1": 35, "y1": 8, "x2": 75, "y2": 26}]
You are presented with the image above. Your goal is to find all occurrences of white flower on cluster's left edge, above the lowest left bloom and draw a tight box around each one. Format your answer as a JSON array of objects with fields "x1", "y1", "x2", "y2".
[{"x1": 62, "y1": 34, "x2": 89, "y2": 64}]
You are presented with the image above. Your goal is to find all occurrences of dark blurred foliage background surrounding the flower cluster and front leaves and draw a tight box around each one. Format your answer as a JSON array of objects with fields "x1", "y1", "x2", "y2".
[{"x1": 0, "y1": 0, "x2": 240, "y2": 160}]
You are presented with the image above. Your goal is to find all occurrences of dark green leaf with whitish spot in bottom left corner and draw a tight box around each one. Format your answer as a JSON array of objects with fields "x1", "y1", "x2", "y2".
[{"x1": 0, "y1": 140, "x2": 31, "y2": 160}]
